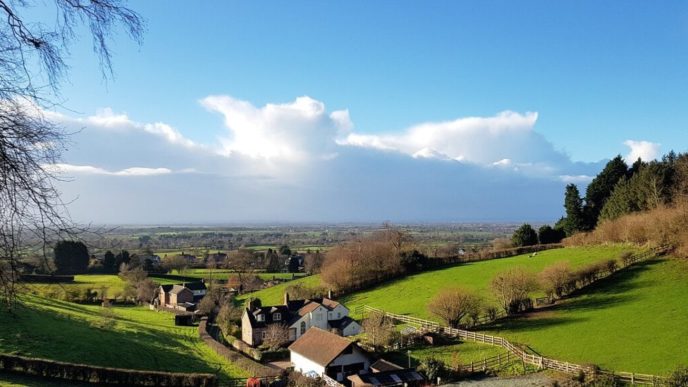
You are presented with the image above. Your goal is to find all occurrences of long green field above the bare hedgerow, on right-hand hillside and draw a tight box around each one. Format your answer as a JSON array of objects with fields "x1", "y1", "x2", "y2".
[{"x1": 338, "y1": 246, "x2": 629, "y2": 321}]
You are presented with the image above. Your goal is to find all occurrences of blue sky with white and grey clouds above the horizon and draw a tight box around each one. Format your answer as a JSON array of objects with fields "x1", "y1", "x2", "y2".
[{"x1": 29, "y1": 0, "x2": 688, "y2": 224}]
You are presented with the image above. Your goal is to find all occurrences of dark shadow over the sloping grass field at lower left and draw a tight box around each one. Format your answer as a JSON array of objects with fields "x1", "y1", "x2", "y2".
[{"x1": 0, "y1": 300, "x2": 226, "y2": 373}]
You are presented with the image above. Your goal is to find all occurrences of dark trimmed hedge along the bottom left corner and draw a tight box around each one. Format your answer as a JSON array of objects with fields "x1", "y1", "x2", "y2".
[{"x1": 0, "y1": 354, "x2": 217, "y2": 387}]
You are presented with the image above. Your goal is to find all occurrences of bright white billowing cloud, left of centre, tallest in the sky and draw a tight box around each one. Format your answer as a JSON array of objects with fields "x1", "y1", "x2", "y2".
[{"x1": 201, "y1": 96, "x2": 353, "y2": 161}]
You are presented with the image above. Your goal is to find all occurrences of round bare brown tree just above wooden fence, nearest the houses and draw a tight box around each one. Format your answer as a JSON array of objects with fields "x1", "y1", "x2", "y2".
[{"x1": 428, "y1": 288, "x2": 481, "y2": 328}]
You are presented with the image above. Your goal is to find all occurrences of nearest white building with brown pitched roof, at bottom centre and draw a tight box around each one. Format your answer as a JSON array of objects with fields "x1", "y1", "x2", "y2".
[{"x1": 289, "y1": 327, "x2": 370, "y2": 382}]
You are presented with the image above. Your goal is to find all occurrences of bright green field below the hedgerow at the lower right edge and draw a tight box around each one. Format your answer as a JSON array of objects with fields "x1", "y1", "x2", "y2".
[{"x1": 487, "y1": 259, "x2": 688, "y2": 375}]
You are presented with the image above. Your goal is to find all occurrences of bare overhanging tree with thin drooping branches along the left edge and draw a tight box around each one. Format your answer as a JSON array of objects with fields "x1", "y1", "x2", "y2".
[{"x1": 0, "y1": 0, "x2": 144, "y2": 309}]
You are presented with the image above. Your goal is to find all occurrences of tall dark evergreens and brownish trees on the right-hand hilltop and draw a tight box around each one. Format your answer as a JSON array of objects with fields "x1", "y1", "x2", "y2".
[{"x1": 557, "y1": 151, "x2": 688, "y2": 236}]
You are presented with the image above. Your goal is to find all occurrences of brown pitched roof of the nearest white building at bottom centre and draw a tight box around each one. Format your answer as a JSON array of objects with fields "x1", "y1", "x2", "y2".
[{"x1": 289, "y1": 327, "x2": 355, "y2": 367}]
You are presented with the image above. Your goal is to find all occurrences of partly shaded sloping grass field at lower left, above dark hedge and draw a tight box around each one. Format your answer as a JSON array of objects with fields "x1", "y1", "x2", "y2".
[{"x1": 0, "y1": 296, "x2": 246, "y2": 378}]
